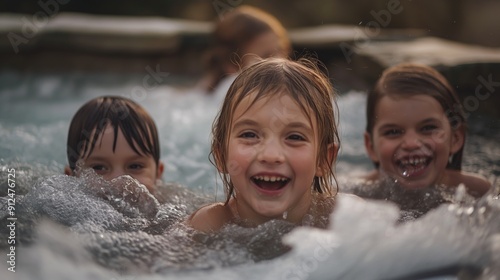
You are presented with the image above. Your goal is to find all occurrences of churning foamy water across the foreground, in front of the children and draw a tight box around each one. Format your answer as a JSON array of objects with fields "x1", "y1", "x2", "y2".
[{"x1": 0, "y1": 179, "x2": 500, "y2": 280}]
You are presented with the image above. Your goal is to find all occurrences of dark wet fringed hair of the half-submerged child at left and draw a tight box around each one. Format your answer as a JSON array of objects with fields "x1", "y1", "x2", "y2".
[{"x1": 66, "y1": 96, "x2": 160, "y2": 172}]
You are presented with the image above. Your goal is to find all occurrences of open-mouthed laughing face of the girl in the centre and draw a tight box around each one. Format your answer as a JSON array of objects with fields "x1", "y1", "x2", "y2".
[{"x1": 226, "y1": 94, "x2": 321, "y2": 224}]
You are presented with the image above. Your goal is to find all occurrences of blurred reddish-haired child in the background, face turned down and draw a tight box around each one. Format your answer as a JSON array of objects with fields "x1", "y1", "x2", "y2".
[{"x1": 200, "y1": 5, "x2": 292, "y2": 94}]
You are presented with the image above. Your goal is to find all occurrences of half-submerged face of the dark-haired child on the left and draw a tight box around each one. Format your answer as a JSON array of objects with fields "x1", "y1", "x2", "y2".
[{"x1": 77, "y1": 125, "x2": 163, "y2": 192}]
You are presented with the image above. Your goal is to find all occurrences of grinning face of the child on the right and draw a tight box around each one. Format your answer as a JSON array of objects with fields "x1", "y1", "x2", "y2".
[{"x1": 365, "y1": 94, "x2": 464, "y2": 189}]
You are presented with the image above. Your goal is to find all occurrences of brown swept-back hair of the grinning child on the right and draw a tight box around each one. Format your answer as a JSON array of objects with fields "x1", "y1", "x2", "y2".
[{"x1": 366, "y1": 63, "x2": 467, "y2": 170}]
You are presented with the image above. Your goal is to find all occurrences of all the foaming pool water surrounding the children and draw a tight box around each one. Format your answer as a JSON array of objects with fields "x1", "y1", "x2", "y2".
[{"x1": 0, "y1": 68, "x2": 500, "y2": 280}]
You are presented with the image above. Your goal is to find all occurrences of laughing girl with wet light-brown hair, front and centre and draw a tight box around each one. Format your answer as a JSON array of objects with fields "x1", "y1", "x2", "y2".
[{"x1": 187, "y1": 58, "x2": 339, "y2": 232}]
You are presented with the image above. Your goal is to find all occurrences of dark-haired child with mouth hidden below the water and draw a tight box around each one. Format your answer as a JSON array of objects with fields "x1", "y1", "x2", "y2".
[{"x1": 64, "y1": 96, "x2": 164, "y2": 193}]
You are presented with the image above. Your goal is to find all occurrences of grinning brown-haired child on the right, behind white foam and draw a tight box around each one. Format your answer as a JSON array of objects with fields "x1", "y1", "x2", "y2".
[{"x1": 364, "y1": 64, "x2": 490, "y2": 197}]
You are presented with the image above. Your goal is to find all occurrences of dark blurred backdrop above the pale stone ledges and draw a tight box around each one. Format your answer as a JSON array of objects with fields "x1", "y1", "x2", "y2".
[{"x1": 0, "y1": 0, "x2": 500, "y2": 47}]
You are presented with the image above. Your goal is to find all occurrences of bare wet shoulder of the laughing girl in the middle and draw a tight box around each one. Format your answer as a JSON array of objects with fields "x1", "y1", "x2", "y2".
[{"x1": 186, "y1": 203, "x2": 232, "y2": 232}]
